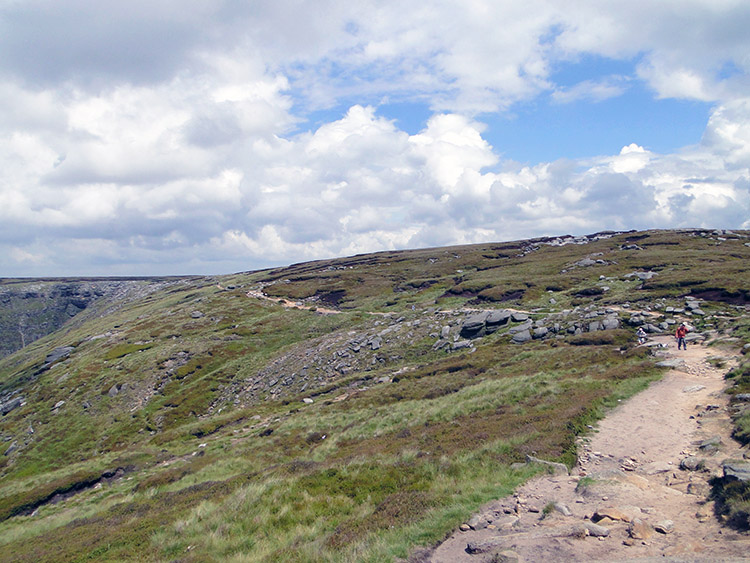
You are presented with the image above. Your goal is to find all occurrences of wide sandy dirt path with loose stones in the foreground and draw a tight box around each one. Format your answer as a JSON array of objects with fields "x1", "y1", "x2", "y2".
[{"x1": 427, "y1": 337, "x2": 750, "y2": 563}]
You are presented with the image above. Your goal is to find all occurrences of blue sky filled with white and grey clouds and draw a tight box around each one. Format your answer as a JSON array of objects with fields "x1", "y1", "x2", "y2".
[{"x1": 0, "y1": 0, "x2": 750, "y2": 277}]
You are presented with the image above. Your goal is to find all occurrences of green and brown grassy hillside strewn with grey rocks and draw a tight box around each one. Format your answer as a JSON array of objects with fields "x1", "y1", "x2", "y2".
[{"x1": 0, "y1": 231, "x2": 750, "y2": 561}]
